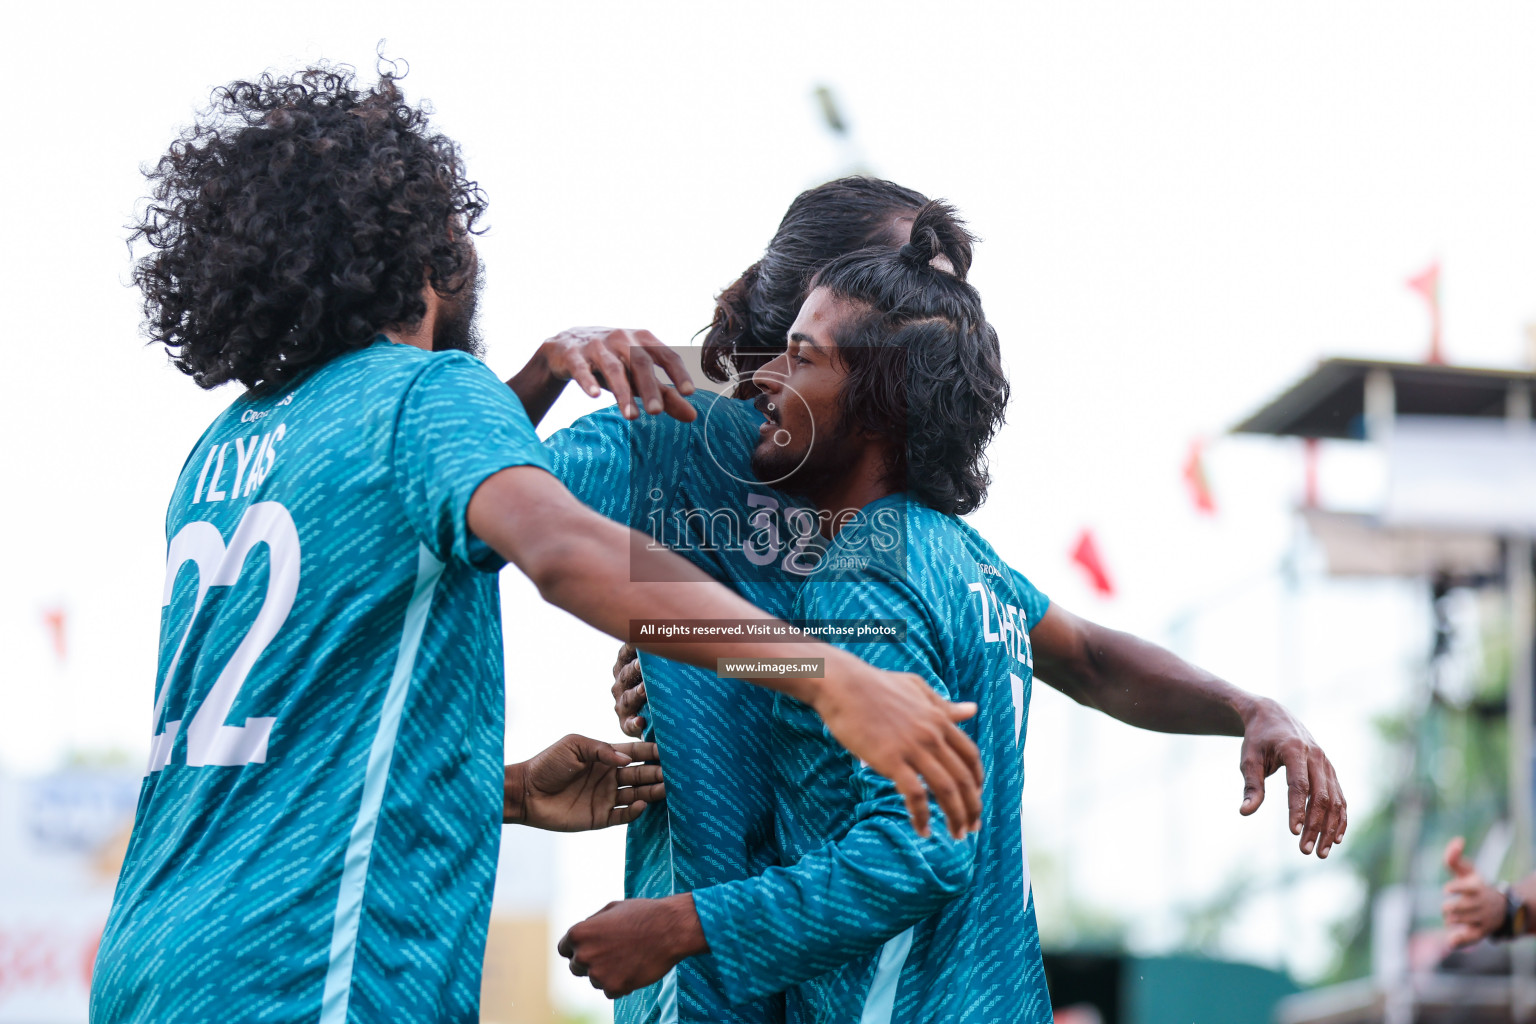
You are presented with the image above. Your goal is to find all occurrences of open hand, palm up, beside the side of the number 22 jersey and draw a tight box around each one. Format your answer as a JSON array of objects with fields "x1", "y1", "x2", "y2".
[{"x1": 502, "y1": 734, "x2": 667, "y2": 832}]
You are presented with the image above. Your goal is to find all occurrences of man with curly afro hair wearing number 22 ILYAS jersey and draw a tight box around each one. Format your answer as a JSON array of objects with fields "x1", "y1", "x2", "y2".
[{"x1": 91, "y1": 66, "x2": 980, "y2": 1024}]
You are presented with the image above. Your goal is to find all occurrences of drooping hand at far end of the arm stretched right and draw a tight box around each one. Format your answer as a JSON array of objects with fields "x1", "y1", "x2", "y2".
[{"x1": 1238, "y1": 699, "x2": 1349, "y2": 858}]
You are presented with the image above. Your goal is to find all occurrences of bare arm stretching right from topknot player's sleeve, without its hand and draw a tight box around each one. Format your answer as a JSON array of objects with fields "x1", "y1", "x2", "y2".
[{"x1": 1031, "y1": 614, "x2": 1267, "y2": 735}]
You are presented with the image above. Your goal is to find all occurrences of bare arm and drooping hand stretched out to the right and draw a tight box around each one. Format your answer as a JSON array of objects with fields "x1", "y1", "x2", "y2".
[{"x1": 1029, "y1": 605, "x2": 1349, "y2": 857}]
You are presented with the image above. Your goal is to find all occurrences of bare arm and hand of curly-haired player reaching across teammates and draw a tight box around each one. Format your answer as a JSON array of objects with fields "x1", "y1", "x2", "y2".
[{"x1": 467, "y1": 465, "x2": 982, "y2": 838}]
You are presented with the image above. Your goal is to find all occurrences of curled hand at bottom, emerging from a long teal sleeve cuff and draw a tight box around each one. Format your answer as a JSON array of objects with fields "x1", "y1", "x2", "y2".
[{"x1": 558, "y1": 892, "x2": 710, "y2": 999}]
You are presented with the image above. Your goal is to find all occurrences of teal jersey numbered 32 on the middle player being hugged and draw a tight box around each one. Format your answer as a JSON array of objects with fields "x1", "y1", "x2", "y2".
[{"x1": 547, "y1": 391, "x2": 820, "y2": 1024}]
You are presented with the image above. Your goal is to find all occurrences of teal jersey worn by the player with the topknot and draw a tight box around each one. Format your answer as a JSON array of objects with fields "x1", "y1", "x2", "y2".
[{"x1": 694, "y1": 494, "x2": 1051, "y2": 1024}]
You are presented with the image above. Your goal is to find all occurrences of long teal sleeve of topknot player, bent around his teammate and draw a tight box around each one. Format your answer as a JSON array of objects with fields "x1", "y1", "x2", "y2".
[{"x1": 693, "y1": 582, "x2": 975, "y2": 999}]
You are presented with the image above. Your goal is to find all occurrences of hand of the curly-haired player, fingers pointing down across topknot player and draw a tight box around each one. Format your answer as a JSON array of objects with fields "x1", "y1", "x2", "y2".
[{"x1": 808, "y1": 651, "x2": 982, "y2": 840}]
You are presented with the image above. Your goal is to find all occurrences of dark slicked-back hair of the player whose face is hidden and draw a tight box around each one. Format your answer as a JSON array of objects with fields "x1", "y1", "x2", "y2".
[{"x1": 700, "y1": 177, "x2": 928, "y2": 386}]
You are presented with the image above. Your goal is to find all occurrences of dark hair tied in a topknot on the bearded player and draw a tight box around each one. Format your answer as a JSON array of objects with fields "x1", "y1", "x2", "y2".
[{"x1": 811, "y1": 201, "x2": 1009, "y2": 516}]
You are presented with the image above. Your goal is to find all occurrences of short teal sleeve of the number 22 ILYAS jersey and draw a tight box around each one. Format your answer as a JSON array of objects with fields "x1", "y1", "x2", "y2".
[{"x1": 392, "y1": 352, "x2": 550, "y2": 571}]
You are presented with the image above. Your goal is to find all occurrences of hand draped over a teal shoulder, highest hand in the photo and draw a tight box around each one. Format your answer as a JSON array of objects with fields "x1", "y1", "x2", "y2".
[{"x1": 539, "y1": 327, "x2": 697, "y2": 422}]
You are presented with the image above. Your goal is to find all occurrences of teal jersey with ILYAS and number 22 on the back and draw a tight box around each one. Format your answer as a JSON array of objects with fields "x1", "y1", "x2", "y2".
[{"x1": 91, "y1": 338, "x2": 548, "y2": 1024}]
